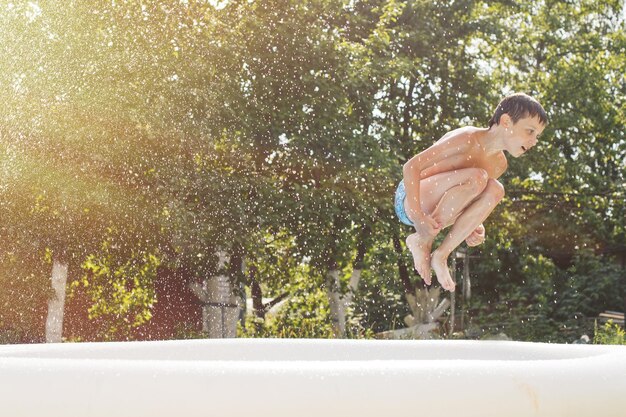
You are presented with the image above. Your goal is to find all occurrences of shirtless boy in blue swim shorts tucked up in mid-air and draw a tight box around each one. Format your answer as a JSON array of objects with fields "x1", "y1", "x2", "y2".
[{"x1": 395, "y1": 93, "x2": 548, "y2": 291}]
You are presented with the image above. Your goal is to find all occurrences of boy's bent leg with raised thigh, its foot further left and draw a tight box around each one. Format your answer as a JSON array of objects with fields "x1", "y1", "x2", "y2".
[{"x1": 405, "y1": 168, "x2": 488, "y2": 285}]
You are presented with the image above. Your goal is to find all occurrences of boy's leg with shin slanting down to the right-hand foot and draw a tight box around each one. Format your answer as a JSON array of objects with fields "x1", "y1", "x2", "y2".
[{"x1": 431, "y1": 179, "x2": 504, "y2": 291}]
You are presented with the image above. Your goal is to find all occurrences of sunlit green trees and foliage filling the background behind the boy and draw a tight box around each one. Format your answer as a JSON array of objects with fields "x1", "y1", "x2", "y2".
[{"x1": 0, "y1": 0, "x2": 626, "y2": 341}]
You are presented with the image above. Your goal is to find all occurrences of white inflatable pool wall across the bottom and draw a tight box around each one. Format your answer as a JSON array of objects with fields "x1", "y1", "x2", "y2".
[{"x1": 0, "y1": 339, "x2": 626, "y2": 417}]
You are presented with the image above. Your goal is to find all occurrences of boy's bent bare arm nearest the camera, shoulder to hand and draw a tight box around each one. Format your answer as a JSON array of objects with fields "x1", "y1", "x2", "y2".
[{"x1": 402, "y1": 134, "x2": 471, "y2": 223}]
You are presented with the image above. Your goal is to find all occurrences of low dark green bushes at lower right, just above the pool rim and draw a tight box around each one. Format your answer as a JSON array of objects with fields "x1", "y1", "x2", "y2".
[{"x1": 470, "y1": 251, "x2": 622, "y2": 343}]
